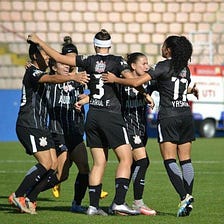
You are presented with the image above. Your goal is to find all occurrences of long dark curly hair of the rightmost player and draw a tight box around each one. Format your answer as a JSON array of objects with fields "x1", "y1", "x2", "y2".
[{"x1": 164, "y1": 36, "x2": 193, "y2": 74}]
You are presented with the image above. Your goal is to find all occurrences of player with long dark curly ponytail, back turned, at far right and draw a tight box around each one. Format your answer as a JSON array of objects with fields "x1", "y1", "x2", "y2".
[{"x1": 103, "y1": 36, "x2": 197, "y2": 217}]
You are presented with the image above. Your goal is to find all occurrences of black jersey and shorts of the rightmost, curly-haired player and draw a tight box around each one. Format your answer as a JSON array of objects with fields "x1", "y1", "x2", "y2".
[{"x1": 148, "y1": 59, "x2": 195, "y2": 144}]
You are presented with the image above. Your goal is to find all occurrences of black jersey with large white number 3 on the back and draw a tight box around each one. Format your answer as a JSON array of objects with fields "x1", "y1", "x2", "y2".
[{"x1": 76, "y1": 54, "x2": 128, "y2": 113}]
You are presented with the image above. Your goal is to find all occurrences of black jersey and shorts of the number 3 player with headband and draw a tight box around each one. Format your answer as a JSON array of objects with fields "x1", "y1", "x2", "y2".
[{"x1": 76, "y1": 54, "x2": 129, "y2": 148}]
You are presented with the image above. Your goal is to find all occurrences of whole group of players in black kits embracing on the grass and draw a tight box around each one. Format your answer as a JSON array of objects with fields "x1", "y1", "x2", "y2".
[{"x1": 9, "y1": 29, "x2": 197, "y2": 217}]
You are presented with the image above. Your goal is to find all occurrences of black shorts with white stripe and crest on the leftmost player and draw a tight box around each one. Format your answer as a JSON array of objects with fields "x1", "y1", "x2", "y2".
[{"x1": 16, "y1": 125, "x2": 55, "y2": 155}]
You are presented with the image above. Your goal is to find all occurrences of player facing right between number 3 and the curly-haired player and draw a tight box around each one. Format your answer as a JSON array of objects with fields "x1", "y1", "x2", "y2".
[{"x1": 121, "y1": 52, "x2": 156, "y2": 215}]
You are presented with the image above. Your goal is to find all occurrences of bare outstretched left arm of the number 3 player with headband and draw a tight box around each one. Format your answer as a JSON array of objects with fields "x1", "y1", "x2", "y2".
[{"x1": 27, "y1": 34, "x2": 76, "y2": 66}]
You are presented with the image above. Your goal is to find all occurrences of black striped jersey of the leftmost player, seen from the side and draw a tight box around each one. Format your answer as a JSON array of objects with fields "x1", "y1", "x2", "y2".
[{"x1": 16, "y1": 65, "x2": 48, "y2": 129}]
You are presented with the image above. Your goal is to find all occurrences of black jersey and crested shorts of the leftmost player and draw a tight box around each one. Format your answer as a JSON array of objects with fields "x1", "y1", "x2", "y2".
[{"x1": 16, "y1": 65, "x2": 54, "y2": 155}]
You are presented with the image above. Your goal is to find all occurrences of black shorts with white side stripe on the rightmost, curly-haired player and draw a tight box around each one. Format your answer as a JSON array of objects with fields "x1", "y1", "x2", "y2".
[{"x1": 157, "y1": 116, "x2": 195, "y2": 145}]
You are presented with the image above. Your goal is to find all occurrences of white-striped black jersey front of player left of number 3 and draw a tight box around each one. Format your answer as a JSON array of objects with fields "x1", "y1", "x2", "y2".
[{"x1": 47, "y1": 81, "x2": 85, "y2": 134}]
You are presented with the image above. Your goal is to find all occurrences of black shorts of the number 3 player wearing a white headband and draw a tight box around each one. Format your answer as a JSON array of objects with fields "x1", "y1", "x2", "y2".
[{"x1": 85, "y1": 109, "x2": 129, "y2": 149}]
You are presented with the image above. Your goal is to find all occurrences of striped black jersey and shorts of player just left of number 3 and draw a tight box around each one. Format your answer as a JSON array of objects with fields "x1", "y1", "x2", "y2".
[{"x1": 47, "y1": 81, "x2": 85, "y2": 151}]
